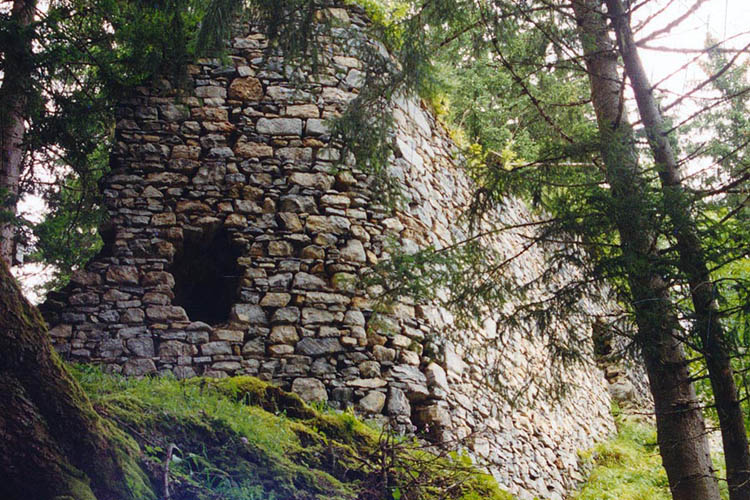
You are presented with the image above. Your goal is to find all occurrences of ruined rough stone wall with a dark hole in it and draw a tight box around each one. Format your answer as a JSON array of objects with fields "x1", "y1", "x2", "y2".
[{"x1": 43, "y1": 5, "x2": 613, "y2": 498}]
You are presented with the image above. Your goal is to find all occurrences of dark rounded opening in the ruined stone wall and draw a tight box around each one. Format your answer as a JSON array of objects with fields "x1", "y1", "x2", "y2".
[{"x1": 170, "y1": 229, "x2": 241, "y2": 326}]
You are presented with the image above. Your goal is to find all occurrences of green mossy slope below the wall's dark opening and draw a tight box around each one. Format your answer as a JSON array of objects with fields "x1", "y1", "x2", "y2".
[{"x1": 74, "y1": 367, "x2": 512, "y2": 500}]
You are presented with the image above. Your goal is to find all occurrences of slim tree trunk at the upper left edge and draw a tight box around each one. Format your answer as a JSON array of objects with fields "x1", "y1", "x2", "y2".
[{"x1": 0, "y1": 0, "x2": 36, "y2": 266}]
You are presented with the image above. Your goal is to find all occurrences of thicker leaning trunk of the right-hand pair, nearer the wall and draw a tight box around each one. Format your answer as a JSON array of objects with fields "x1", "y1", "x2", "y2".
[{"x1": 573, "y1": 0, "x2": 720, "y2": 500}]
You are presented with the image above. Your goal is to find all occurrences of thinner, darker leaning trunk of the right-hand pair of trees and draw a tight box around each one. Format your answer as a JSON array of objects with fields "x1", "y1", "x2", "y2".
[{"x1": 606, "y1": 0, "x2": 750, "y2": 500}]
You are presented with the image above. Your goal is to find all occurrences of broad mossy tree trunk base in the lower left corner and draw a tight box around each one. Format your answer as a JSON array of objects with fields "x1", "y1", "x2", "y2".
[{"x1": 0, "y1": 262, "x2": 154, "y2": 500}]
